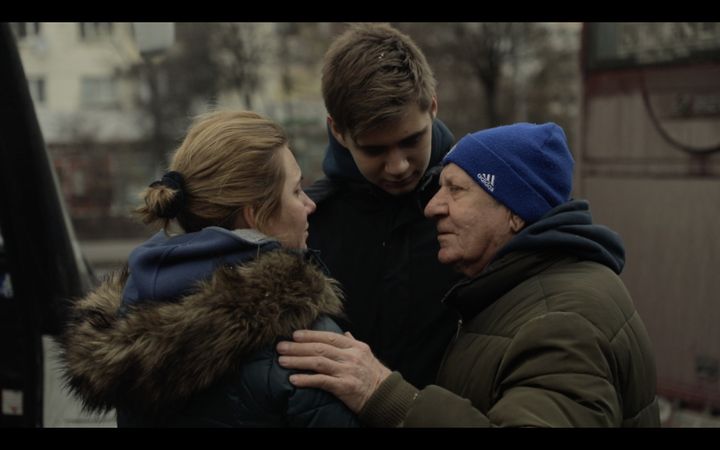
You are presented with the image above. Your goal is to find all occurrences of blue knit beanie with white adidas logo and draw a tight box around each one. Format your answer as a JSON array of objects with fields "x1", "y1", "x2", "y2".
[{"x1": 442, "y1": 122, "x2": 574, "y2": 223}]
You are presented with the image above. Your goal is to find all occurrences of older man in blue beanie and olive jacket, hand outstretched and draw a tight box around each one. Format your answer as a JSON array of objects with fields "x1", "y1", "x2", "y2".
[{"x1": 278, "y1": 123, "x2": 660, "y2": 427}]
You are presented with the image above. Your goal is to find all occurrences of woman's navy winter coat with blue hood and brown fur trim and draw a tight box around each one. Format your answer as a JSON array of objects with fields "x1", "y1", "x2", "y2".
[{"x1": 61, "y1": 227, "x2": 358, "y2": 427}]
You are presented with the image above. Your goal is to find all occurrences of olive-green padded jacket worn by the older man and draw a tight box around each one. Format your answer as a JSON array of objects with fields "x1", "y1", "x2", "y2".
[{"x1": 360, "y1": 201, "x2": 660, "y2": 427}]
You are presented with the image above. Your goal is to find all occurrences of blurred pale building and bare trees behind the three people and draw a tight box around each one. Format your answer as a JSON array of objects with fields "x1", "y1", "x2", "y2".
[{"x1": 12, "y1": 22, "x2": 580, "y2": 239}]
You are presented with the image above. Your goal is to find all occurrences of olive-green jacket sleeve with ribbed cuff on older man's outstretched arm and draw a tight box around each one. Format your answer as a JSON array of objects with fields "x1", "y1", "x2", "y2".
[{"x1": 360, "y1": 313, "x2": 622, "y2": 427}]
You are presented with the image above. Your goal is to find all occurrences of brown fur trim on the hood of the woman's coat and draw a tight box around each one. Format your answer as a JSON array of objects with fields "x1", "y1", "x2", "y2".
[{"x1": 60, "y1": 250, "x2": 342, "y2": 413}]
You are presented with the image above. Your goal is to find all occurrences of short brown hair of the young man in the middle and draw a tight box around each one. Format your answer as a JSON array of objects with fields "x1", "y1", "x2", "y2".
[{"x1": 322, "y1": 23, "x2": 436, "y2": 140}]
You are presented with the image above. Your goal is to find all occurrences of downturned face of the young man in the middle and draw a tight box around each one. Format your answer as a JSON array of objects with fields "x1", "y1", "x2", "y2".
[{"x1": 330, "y1": 99, "x2": 437, "y2": 195}]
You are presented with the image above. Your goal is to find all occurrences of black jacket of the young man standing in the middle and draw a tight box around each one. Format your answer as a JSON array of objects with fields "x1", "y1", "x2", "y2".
[{"x1": 307, "y1": 119, "x2": 460, "y2": 386}]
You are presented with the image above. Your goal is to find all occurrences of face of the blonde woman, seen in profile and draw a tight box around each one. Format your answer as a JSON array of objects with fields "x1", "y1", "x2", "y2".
[{"x1": 264, "y1": 146, "x2": 315, "y2": 248}]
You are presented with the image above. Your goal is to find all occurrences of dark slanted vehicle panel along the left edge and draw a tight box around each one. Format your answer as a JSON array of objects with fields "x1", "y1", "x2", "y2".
[{"x1": 0, "y1": 23, "x2": 90, "y2": 427}]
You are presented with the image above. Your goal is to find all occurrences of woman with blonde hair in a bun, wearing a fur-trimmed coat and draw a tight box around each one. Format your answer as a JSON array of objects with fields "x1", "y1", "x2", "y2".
[{"x1": 60, "y1": 111, "x2": 357, "y2": 427}]
